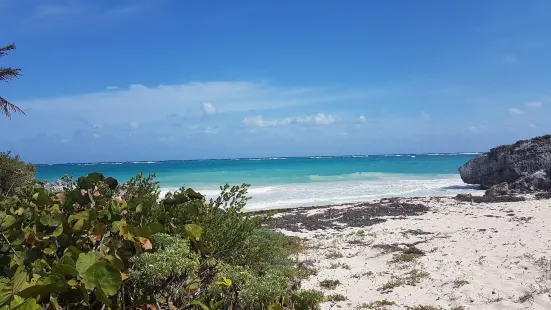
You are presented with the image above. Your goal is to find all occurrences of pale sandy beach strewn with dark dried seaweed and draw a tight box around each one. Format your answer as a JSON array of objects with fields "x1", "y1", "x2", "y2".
[{"x1": 276, "y1": 197, "x2": 551, "y2": 310}]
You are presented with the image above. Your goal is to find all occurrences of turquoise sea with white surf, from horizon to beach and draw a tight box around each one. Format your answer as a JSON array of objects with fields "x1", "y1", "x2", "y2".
[{"x1": 37, "y1": 153, "x2": 484, "y2": 210}]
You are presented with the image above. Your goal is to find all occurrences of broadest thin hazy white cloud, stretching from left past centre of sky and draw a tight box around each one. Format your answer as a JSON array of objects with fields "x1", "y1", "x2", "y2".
[{"x1": 14, "y1": 81, "x2": 367, "y2": 125}]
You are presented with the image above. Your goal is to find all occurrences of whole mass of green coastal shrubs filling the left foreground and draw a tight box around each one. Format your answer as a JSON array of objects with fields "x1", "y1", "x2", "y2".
[{"x1": 0, "y1": 153, "x2": 324, "y2": 310}]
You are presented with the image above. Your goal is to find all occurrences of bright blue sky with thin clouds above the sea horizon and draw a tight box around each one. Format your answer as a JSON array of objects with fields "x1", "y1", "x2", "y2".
[{"x1": 0, "y1": 0, "x2": 551, "y2": 163}]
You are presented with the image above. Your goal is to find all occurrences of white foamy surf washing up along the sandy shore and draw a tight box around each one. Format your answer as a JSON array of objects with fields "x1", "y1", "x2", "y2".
[{"x1": 161, "y1": 173, "x2": 481, "y2": 210}]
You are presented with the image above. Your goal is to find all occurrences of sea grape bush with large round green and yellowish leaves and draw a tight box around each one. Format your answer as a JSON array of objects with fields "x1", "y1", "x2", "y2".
[{"x1": 0, "y1": 174, "x2": 216, "y2": 309}]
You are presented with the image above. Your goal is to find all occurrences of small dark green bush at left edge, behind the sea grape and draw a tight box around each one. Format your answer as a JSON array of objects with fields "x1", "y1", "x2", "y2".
[{"x1": 0, "y1": 152, "x2": 36, "y2": 196}]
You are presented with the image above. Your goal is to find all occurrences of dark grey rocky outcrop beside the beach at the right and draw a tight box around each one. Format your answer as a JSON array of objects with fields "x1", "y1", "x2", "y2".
[{"x1": 459, "y1": 135, "x2": 551, "y2": 194}]
